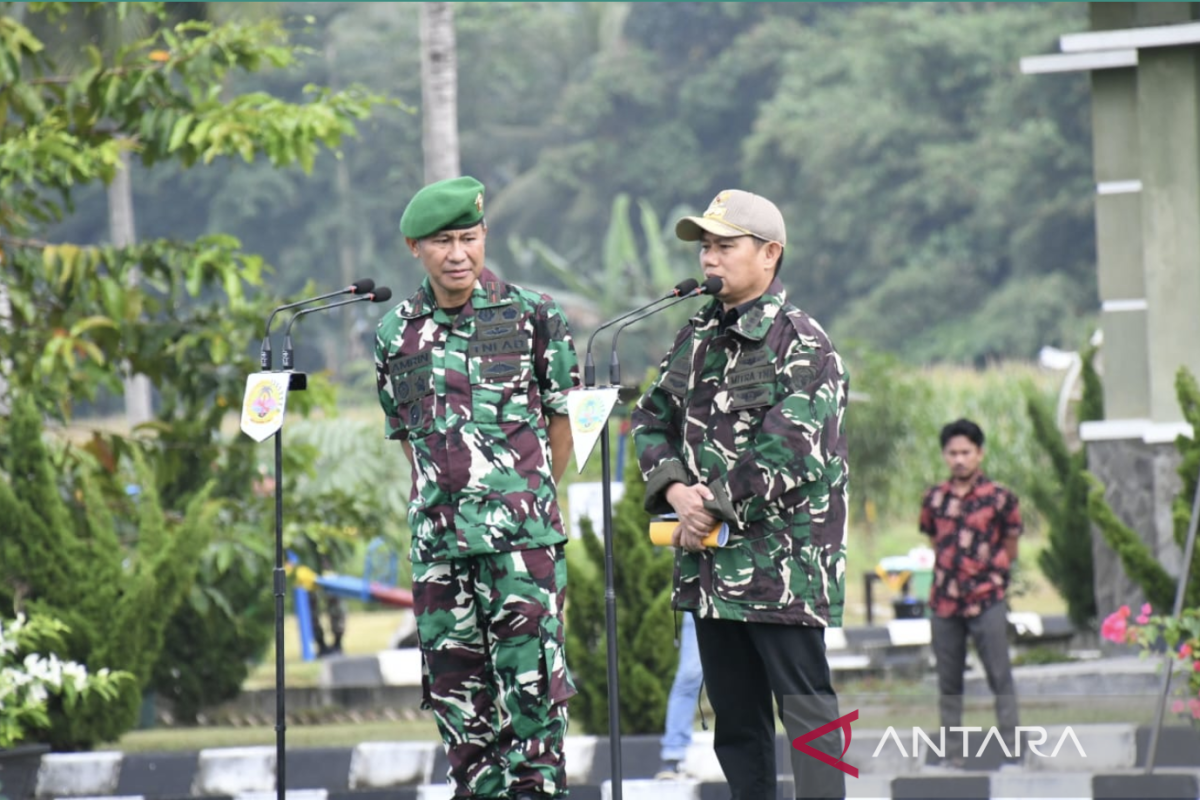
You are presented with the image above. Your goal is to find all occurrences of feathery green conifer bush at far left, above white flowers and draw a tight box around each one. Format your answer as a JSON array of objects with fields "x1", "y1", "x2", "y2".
[{"x1": 0, "y1": 395, "x2": 211, "y2": 750}]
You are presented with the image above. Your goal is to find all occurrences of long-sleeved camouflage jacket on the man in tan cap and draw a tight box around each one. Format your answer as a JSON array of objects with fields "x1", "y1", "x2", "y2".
[{"x1": 634, "y1": 279, "x2": 848, "y2": 626}]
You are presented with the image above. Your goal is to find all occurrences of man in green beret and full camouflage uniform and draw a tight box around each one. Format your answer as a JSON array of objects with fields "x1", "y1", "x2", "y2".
[{"x1": 376, "y1": 178, "x2": 578, "y2": 800}]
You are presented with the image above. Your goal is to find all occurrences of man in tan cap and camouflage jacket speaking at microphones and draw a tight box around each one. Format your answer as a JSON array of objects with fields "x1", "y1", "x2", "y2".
[{"x1": 634, "y1": 190, "x2": 852, "y2": 800}]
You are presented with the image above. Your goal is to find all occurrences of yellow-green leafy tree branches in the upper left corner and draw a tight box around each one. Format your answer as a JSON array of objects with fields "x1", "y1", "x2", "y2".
[{"x1": 0, "y1": 4, "x2": 379, "y2": 419}]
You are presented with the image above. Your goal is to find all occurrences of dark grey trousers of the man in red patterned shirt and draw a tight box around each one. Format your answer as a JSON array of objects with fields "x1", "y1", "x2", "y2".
[{"x1": 931, "y1": 602, "x2": 1020, "y2": 757}]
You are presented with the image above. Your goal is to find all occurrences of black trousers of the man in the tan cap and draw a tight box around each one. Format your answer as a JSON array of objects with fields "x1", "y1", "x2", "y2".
[{"x1": 696, "y1": 619, "x2": 846, "y2": 800}]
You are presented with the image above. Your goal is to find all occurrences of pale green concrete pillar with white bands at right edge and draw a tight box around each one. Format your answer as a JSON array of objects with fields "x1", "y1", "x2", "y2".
[{"x1": 1080, "y1": 2, "x2": 1200, "y2": 618}]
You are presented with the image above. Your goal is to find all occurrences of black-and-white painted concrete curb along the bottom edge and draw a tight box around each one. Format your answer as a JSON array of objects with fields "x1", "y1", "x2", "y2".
[{"x1": 13, "y1": 724, "x2": 1200, "y2": 800}]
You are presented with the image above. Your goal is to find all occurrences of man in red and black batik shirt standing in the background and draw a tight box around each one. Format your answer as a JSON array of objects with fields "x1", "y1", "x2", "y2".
[{"x1": 920, "y1": 420, "x2": 1021, "y2": 766}]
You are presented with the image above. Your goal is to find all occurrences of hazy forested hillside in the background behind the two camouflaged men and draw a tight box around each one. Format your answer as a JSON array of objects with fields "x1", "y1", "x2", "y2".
[{"x1": 28, "y1": 2, "x2": 1096, "y2": 378}]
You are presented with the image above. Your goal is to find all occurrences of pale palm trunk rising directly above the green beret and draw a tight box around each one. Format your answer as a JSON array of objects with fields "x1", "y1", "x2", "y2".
[{"x1": 421, "y1": 2, "x2": 461, "y2": 184}]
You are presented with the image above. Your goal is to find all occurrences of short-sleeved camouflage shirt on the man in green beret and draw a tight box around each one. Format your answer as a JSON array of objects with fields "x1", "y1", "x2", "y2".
[{"x1": 376, "y1": 270, "x2": 578, "y2": 561}]
